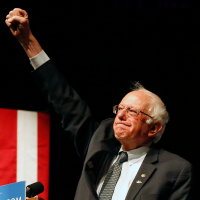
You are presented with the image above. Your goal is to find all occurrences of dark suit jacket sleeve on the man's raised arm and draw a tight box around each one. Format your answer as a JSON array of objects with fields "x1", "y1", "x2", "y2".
[{"x1": 32, "y1": 60, "x2": 98, "y2": 159}]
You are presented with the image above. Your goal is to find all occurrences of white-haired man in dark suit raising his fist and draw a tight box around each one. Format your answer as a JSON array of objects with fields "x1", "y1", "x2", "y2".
[{"x1": 6, "y1": 9, "x2": 192, "y2": 200}]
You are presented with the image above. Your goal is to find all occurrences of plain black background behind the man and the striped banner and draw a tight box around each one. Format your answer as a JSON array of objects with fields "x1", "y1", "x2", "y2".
[{"x1": 0, "y1": 1, "x2": 200, "y2": 200}]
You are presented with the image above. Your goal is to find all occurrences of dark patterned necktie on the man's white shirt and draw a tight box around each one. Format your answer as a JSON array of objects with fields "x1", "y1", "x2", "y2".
[{"x1": 99, "y1": 152, "x2": 128, "y2": 200}]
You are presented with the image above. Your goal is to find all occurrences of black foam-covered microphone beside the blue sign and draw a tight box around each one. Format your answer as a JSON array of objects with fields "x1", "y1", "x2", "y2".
[{"x1": 26, "y1": 182, "x2": 44, "y2": 197}]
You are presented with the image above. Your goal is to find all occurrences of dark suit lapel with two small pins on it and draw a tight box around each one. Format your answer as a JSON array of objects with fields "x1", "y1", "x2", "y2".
[{"x1": 126, "y1": 148, "x2": 158, "y2": 200}]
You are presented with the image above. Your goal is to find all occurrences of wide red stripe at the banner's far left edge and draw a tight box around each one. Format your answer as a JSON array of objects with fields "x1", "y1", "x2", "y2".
[{"x1": 0, "y1": 108, "x2": 17, "y2": 186}]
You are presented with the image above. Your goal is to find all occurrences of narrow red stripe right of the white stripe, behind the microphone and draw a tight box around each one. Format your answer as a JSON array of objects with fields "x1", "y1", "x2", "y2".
[{"x1": 38, "y1": 113, "x2": 50, "y2": 200}]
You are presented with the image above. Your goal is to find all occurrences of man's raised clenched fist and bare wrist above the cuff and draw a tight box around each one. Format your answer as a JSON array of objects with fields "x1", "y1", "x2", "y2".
[{"x1": 5, "y1": 8, "x2": 42, "y2": 58}]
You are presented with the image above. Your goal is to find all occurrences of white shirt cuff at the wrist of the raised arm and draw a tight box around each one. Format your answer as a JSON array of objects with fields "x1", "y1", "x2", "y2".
[{"x1": 30, "y1": 50, "x2": 50, "y2": 69}]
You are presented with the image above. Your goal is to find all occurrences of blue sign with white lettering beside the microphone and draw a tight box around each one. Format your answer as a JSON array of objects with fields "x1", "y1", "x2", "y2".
[{"x1": 0, "y1": 181, "x2": 26, "y2": 200}]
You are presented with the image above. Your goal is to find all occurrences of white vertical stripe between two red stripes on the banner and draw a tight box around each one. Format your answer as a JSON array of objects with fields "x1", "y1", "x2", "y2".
[{"x1": 17, "y1": 110, "x2": 38, "y2": 185}]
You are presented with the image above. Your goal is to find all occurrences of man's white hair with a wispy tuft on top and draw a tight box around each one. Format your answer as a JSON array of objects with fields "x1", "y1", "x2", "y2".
[{"x1": 132, "y1": 82, "x2": 169, "y2": 143}]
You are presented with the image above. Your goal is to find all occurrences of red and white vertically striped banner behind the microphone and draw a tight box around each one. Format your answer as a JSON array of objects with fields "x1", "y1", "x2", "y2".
[{"x1": 0, "y1": 108, "x2": 50, "y2": 200}]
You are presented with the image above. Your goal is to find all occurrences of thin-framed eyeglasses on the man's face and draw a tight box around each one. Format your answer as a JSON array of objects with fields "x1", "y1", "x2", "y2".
[{"x1": 113, "y1": 105, "x2": 153, "y2": 119}]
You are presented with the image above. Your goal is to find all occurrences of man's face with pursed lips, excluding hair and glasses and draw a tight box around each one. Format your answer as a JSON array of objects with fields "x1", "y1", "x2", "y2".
[{"x1": 113, "y1": 91, "x2": 152, "y2": 150}]
